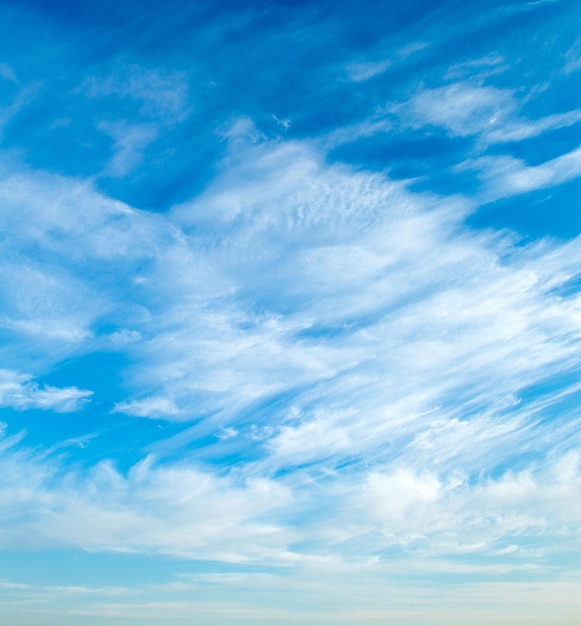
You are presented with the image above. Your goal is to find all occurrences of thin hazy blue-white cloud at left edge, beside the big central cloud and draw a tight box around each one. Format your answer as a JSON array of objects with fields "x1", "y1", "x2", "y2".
[{"x1": 0, "y1": 171, "x2": 189, "y2": 371}]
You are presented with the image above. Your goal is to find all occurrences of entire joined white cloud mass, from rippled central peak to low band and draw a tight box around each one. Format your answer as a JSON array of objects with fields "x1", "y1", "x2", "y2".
[{"x1": 2, "y1": 124, "x2": 581, "y2": 567}]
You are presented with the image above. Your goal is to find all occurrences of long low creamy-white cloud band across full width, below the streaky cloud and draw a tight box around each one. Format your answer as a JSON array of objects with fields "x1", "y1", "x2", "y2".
[{"x1": 0, "y1": 422, "x2": 581, "y2": 573}]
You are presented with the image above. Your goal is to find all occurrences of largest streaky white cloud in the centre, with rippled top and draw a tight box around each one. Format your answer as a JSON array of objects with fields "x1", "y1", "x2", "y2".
[{"x1": 164, "y1": 135, "x2": 574, "y2": 445}]
